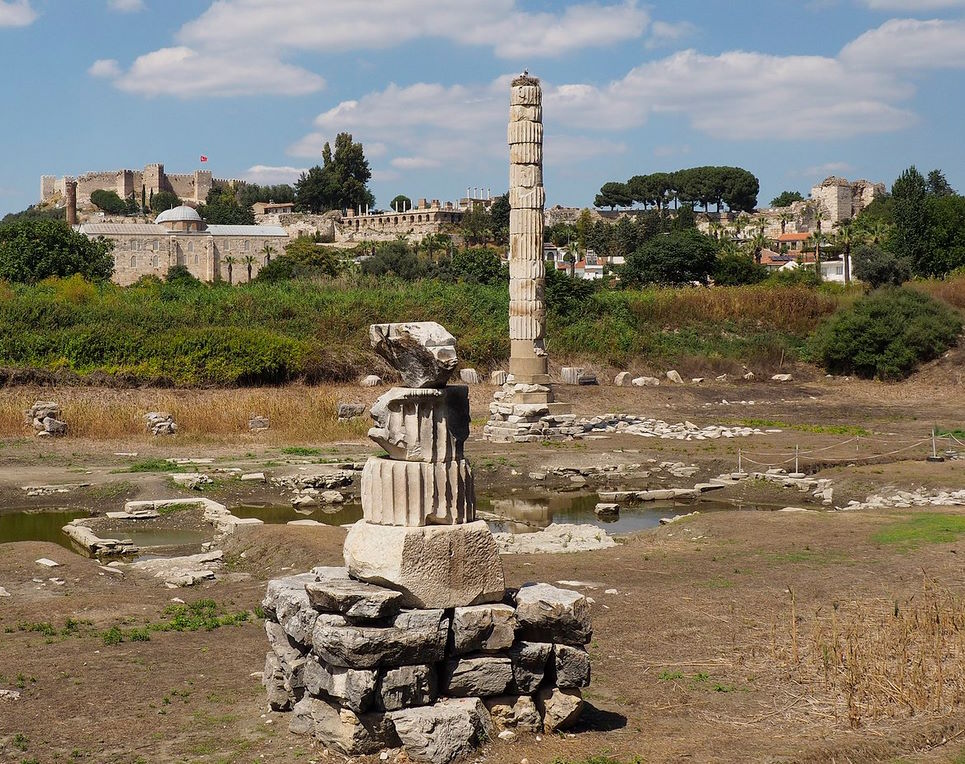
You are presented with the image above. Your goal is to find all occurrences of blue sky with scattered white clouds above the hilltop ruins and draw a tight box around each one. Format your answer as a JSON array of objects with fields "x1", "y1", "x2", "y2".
[{"x1": 0, "y1": 0, "x2": 965, "y2": 214}]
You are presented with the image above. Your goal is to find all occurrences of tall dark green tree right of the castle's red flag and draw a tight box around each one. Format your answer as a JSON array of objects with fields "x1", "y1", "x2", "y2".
[{"x1": 295, "y1": 133, "x2": 372, "y2": 213}]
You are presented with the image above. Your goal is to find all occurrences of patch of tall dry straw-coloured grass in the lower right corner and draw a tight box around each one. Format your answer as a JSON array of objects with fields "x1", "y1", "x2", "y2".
[{"x1": 772, "y1": 577, "x2": 965, "y2": 728}]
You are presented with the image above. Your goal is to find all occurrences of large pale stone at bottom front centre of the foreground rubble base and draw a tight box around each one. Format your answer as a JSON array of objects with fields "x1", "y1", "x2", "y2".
[{"x1": 387, "y1": 698, "x2": 496, "y2": 764}]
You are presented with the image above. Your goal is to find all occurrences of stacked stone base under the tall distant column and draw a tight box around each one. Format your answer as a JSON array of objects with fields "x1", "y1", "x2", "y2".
[{"x1": 483, "y1": 383, "x2": 584, "y2": 443}]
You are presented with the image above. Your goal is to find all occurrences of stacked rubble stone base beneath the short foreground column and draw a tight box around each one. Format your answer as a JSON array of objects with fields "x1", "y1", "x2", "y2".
[{"x1": 264, "y1": 568, "x2": 592, "y2": 762}]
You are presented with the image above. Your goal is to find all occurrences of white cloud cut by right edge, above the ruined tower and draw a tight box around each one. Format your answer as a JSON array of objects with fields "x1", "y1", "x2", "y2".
[{"x1": 840, "y1": 19, "x2": 965, "y2": 71}]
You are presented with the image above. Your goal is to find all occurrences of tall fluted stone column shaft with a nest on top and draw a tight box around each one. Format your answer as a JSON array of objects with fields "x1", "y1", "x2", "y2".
[{"x1": 507, "y1": 75, "x2": 549, "y2": 384}]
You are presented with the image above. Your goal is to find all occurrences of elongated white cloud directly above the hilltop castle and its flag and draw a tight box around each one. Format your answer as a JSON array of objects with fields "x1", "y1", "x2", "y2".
[{"x1": 104, "y1": 46, "x2": 325, "y2": 98}]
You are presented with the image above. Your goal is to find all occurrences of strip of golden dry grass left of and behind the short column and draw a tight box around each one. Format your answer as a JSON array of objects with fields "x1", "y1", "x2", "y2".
[{"x1": 0, "y1": 385, "x2": 370, "y2": 443}]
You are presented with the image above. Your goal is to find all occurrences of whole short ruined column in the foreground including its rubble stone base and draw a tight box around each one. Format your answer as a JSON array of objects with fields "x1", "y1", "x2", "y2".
[{"x1": 264, "y1": 322, "x2": 591, "y2": 762}]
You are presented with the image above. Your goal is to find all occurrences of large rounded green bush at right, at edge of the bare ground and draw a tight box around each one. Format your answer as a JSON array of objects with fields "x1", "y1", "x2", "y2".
[{"x1": 811, "y1": 289, "x2": 962, "y2": 380}]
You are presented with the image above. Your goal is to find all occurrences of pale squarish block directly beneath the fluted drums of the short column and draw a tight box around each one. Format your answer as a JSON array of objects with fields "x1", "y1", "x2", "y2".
[{"x1": 344, "y1": 520, "x2": 505, "y2": 608}]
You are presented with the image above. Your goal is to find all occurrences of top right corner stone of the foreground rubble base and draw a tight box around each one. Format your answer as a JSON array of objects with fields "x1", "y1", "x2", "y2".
[{"x1": 516, "y1": 584, "x2": 593, "y2": 645}]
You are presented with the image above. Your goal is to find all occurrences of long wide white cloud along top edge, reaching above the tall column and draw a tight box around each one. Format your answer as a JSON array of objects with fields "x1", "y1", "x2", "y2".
[{"x1": 179, "y1": 0, "x2": 649, "y2": 59}]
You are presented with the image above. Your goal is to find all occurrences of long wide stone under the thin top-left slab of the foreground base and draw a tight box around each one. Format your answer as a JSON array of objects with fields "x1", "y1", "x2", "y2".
[{"x1": 312, "y1": 610, "x2": 449, "y2": 668}]
